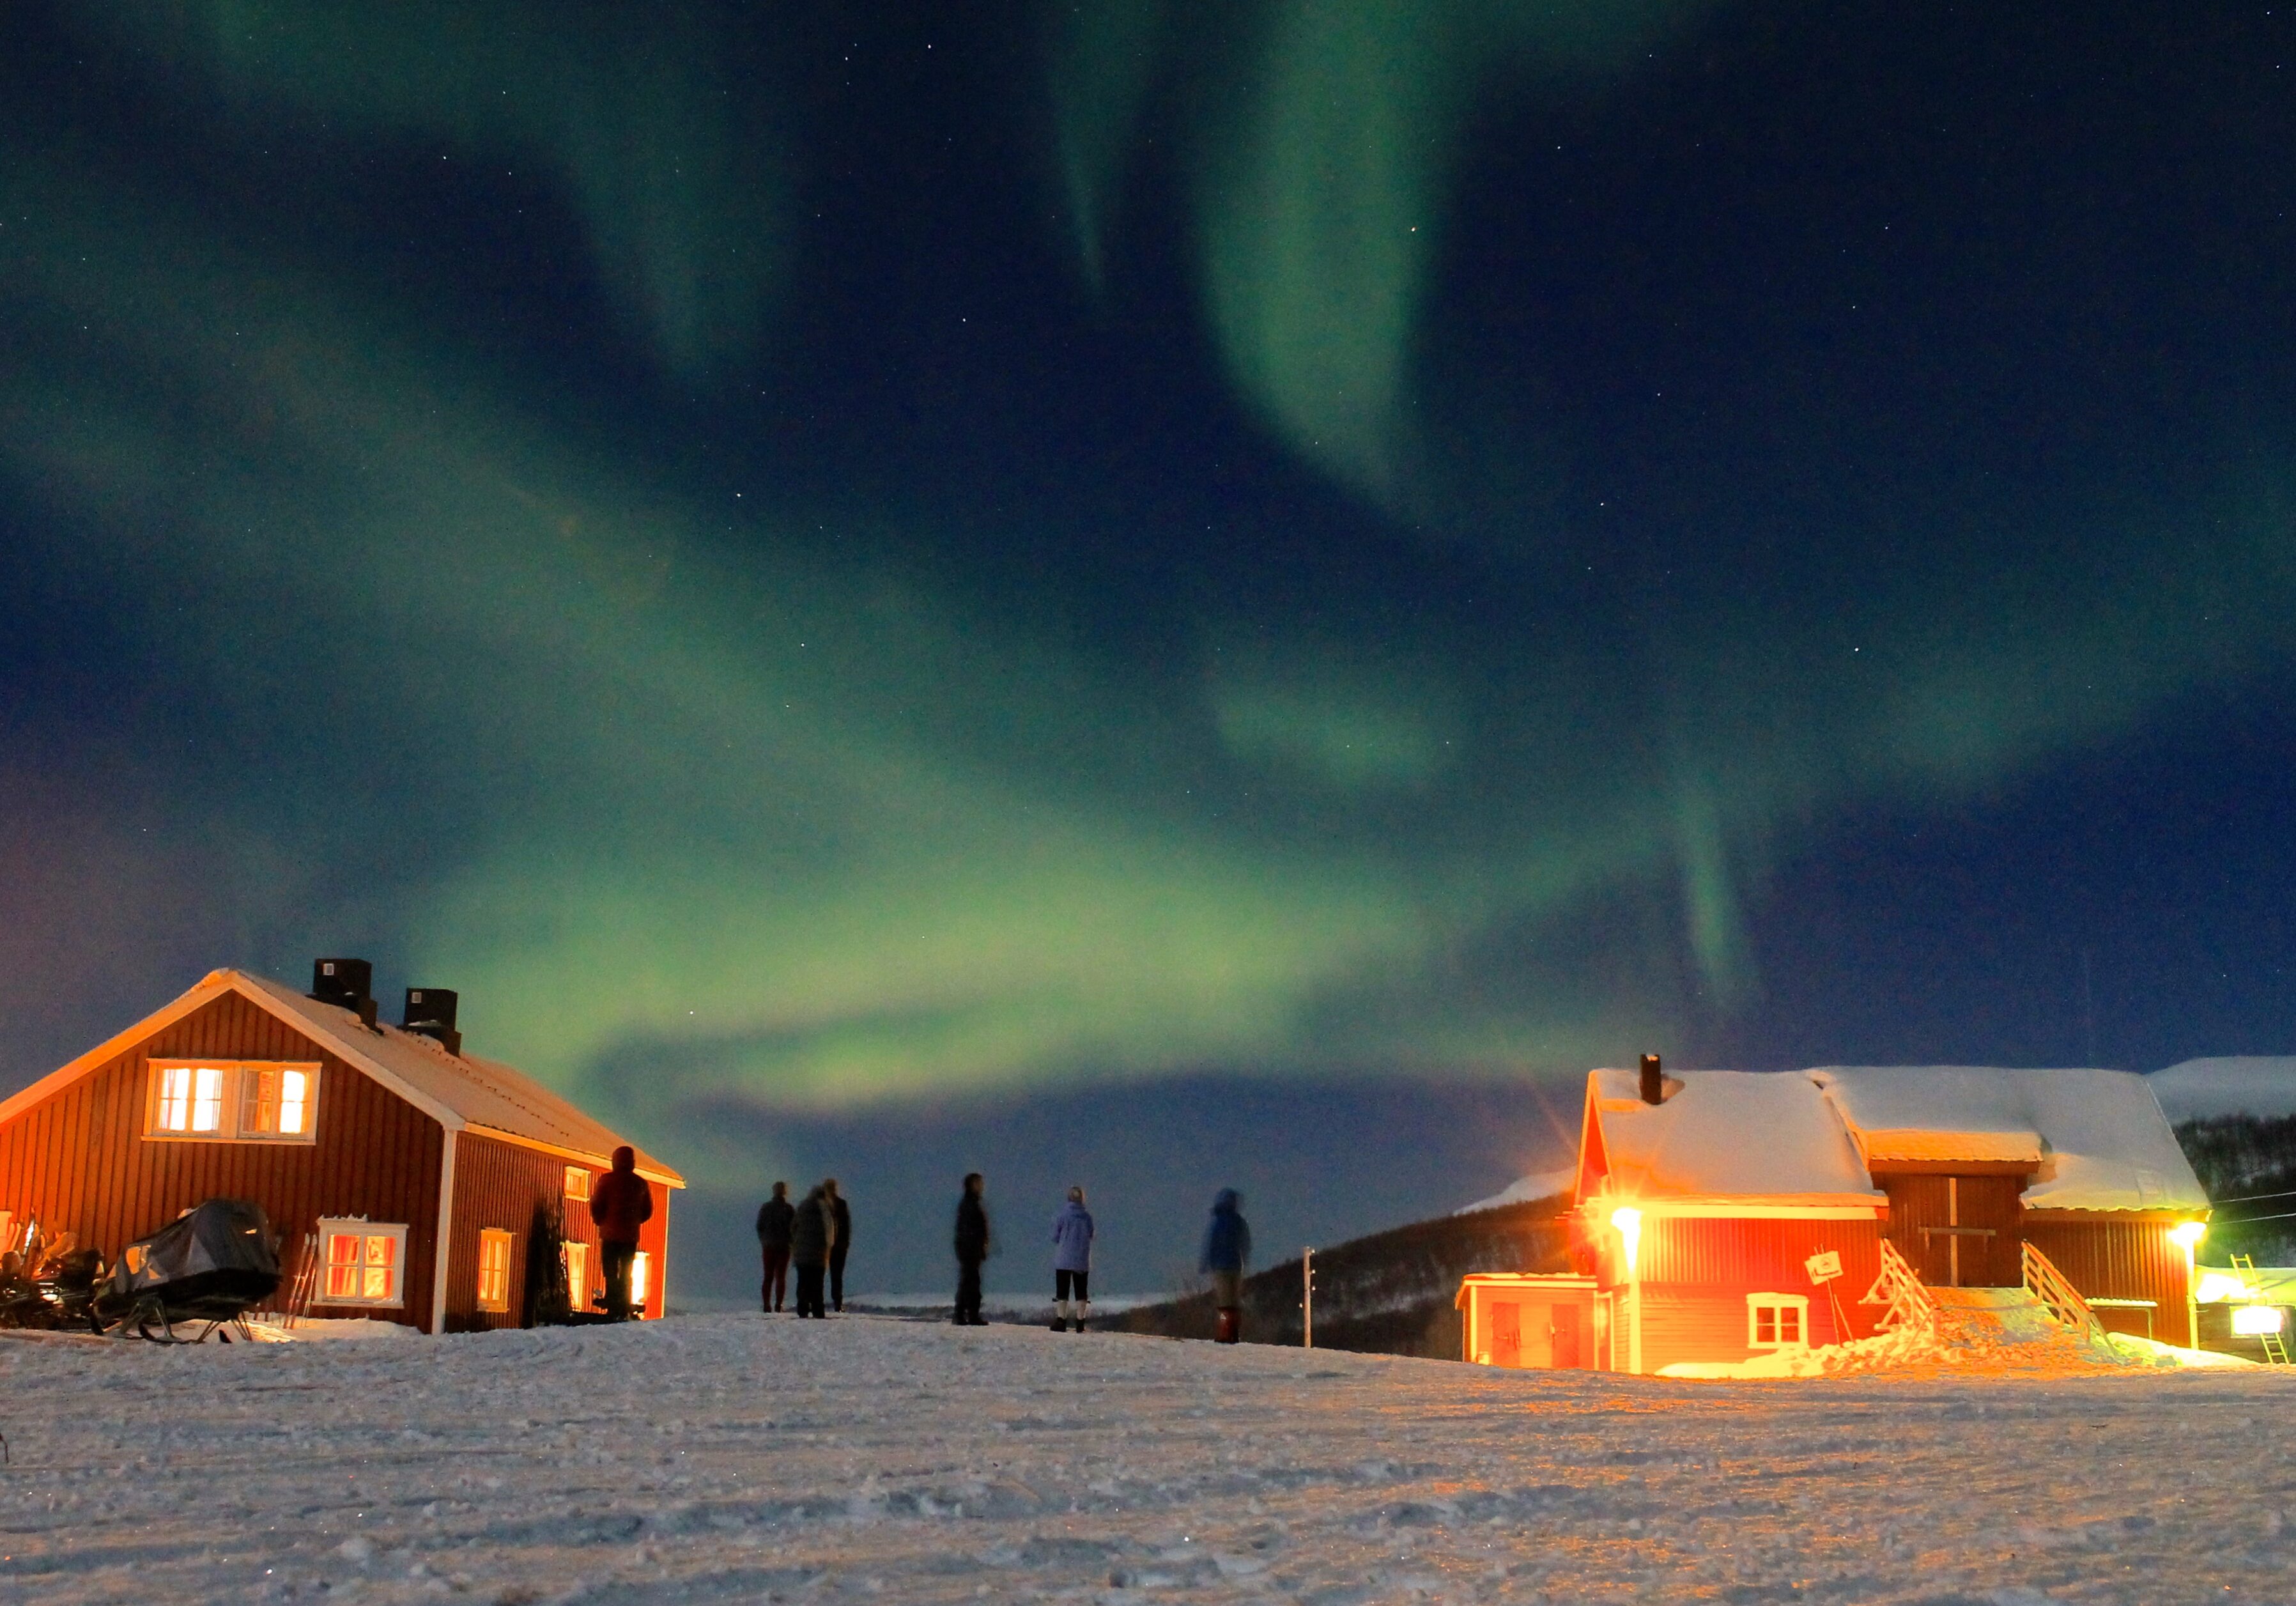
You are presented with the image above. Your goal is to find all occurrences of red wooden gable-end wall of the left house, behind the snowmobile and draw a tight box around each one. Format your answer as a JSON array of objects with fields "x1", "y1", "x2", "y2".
[{"x1": 0, "y1": 992, "x2": 443, "y2": 1325}]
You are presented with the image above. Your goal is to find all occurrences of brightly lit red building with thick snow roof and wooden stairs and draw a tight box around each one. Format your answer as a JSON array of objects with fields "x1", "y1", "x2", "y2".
[{"x1": 1460, "y1": 1057, "x2": 2208, "y2": 1371}]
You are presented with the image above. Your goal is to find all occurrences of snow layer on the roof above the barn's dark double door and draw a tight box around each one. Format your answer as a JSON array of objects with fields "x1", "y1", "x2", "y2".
[{"x1": 1807, "y1": 1066, "x2": 2208, "y2": 1211}]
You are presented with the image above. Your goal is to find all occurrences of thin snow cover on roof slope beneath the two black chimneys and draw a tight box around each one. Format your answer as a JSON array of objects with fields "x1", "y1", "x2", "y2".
[{"x1": 228, "y1": 969, "x2": 684, "y2": 1185}]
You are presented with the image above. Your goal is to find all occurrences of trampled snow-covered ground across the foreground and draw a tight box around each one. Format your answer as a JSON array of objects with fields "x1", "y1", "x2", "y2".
[{"x1": 0, "y1": 1314, "x2": 2296, "y2": 1606}]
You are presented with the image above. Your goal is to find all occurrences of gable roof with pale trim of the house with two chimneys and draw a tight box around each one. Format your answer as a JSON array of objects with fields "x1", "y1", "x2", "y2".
[{"x1": 0, "y1": 969, "x2": 686, "y2": 1188}]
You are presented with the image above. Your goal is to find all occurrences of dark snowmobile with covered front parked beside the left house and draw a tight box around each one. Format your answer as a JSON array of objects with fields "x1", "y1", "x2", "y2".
[{"x1": 92, "y1": 1200, "x2": 280, "y2": 1344}]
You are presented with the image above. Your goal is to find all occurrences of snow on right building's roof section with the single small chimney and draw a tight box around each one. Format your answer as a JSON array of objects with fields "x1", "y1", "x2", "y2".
[{"x1": 1587, "y1": 1070, "x2": 1881, "y2": 1204}]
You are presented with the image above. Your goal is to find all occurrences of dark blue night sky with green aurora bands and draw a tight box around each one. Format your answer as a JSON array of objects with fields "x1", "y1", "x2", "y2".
[{"x1": 0, "y1": 0, "x2": 2296, "y2": 1296}]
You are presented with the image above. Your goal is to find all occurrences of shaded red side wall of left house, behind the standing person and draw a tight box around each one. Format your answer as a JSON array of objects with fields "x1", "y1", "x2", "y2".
[{"x1": 445, "y1": 1132, "x2": 670, "y2": 1332}]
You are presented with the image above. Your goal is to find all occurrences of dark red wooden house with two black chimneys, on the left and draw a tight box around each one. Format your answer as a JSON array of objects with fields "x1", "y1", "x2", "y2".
[{"x1": 0, "y1": 961, "x2": 684, "y2": 1332}]
